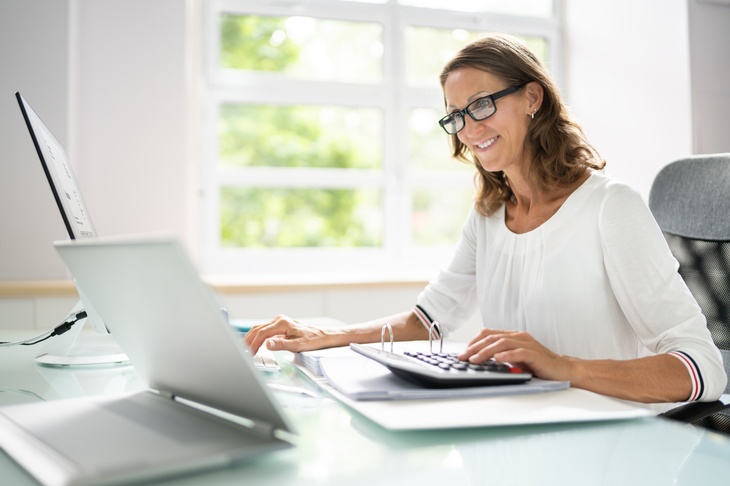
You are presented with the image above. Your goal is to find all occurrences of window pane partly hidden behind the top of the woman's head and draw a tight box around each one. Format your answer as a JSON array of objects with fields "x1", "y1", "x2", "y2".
[{"x1": 406, "y1": 27, "x2": 548, "y2": 89}]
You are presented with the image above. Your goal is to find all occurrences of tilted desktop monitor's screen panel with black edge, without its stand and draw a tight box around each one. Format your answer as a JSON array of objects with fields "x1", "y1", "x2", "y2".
[{"x1": 15, "y1": 93, "x2": 95, "y2": 239}]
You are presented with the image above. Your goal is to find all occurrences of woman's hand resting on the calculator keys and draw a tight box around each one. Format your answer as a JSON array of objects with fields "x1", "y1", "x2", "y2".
[{"x1": 459, "y1": 329, "x2": 572, "y2": 381}]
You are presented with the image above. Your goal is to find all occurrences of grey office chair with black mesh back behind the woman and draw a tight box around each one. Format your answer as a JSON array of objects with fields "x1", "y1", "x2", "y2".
[{"x1": 649, "y1": 153, "x2": 730, "y2": 435}]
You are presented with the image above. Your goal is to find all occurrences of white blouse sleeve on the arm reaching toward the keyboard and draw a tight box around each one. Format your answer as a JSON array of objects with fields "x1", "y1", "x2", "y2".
[{"x1": 414, "y1": 208, "x2": 479, "y2": 335}]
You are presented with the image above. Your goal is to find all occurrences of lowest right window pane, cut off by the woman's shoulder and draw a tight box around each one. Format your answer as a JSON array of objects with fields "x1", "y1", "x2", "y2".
[{"x1": 411, "y1": 186, "x2": 474, "y2": 246}]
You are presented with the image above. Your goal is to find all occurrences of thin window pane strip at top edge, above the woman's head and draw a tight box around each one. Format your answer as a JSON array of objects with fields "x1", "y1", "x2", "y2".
[{"x1": 398, "y1": 0, "x2": 553, "y2": 18}]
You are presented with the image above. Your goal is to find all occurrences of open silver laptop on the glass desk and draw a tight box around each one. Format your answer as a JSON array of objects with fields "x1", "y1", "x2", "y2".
[{"x1": 0, "y1": 238, "x2": 295, "y2": 485}]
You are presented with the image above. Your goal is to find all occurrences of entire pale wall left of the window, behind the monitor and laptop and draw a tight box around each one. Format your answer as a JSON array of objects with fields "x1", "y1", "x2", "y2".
[{"x1": 0, "y1": 0, "x2": 193, "y2": 280}]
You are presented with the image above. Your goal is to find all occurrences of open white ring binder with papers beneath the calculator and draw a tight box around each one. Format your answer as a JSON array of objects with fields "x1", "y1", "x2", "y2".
[{"x1": 294, "y1": 341, "x2": 654, "y2": 430}]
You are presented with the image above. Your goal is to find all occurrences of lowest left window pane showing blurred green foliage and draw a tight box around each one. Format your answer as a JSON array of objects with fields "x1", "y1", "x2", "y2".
[{"x1": 220, "y1": 187, "x2": 383, "y2": 248}]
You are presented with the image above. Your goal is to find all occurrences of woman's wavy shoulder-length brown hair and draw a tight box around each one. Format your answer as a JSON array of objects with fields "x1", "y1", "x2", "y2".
[{"x1": 441, "y1": 34, "x2": 606, "y2": 216}]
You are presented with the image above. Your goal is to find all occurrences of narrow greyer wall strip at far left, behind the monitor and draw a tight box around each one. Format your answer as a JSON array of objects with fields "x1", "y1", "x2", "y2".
[{"x1": 0, "y1": 0, "x2": 69, "y2": 279}]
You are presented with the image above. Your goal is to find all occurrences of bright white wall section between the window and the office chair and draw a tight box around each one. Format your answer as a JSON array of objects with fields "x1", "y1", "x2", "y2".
[{"x1": 564, "y1": 0, "x2": 692, "y2": 198}]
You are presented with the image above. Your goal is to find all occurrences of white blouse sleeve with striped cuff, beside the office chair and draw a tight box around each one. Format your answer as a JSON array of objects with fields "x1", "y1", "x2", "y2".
[{"x1": 599, "y1": 180, "x2": 727, "y2": 401}]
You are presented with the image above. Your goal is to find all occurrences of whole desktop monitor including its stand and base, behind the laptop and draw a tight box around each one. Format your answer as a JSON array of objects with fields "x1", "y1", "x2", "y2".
[{"x1": 15, "y1": 92, "x2": 126, "y2": 366}]
